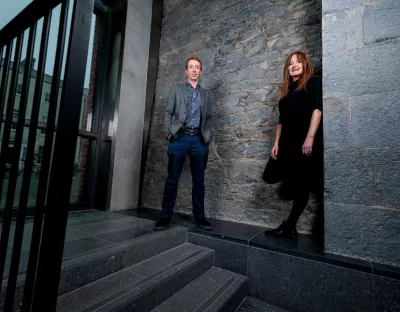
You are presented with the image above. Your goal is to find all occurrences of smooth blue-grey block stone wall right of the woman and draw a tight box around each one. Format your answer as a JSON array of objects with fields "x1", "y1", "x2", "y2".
[{"x1": 323, "y1": 0, "x2": 400, "y2": 265}]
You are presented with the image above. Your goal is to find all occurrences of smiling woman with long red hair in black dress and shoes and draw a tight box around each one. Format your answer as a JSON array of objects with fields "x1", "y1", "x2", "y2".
[{"x1": 265, "y1": 51, "x2": 322, "y2": 238}]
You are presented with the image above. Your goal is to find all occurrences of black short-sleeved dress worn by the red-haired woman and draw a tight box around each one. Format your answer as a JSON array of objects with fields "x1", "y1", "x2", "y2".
[{"x1": 278, "y1": 76, "x2": 323, "y2": 191}]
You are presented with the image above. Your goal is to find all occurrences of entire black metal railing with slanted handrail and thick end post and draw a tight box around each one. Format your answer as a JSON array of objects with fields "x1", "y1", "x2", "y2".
[{"x1": 0, "y1": 0, "x2": 94, "y2": 312}]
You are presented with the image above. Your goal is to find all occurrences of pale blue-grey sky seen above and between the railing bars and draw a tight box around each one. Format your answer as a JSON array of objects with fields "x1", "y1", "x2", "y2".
[{"x1": 0, "y1": 0, "x2": 95, "y2": 88}]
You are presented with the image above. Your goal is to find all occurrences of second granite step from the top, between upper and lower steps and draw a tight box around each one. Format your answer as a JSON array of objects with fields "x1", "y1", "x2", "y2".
[{"x1": 57, "y1": 243, "x2": 214, "y2": 312}]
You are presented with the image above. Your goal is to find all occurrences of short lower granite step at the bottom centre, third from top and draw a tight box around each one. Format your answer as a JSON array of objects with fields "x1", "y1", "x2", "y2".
[{"x1": 152, "y1": 267, "x2": 247, "y2": 312}]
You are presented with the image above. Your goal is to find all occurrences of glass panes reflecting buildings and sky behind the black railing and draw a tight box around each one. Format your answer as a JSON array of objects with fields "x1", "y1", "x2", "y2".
[{"x1": 0, "y1": 5, "x2": 106, "y2": 209}]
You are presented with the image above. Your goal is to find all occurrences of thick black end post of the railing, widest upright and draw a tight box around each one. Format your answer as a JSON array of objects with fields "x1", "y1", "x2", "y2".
[{"x1": 32, "y1": 0, "x2": 94, "y2": 312}]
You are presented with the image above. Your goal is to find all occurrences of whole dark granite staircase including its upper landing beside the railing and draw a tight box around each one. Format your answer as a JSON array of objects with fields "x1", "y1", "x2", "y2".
[{"x1": 0, "y1": 211, "x2": 288, "y2": 312}]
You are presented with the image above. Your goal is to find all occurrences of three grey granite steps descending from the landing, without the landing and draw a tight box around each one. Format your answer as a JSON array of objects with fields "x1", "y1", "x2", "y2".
[{"x1": 57, "y1": 225, "x2": 247, "y2": 312}]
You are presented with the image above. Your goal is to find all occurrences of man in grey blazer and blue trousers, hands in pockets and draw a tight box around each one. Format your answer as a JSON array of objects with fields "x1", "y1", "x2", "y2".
[{"x1": 154, "y1": 57, "x2": 213, "y2": 231}]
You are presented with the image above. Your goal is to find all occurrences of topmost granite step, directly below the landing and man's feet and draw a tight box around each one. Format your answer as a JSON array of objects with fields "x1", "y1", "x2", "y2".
[{"x1": 0, "y1": 227, "x2": 187, "y2": 311}]
